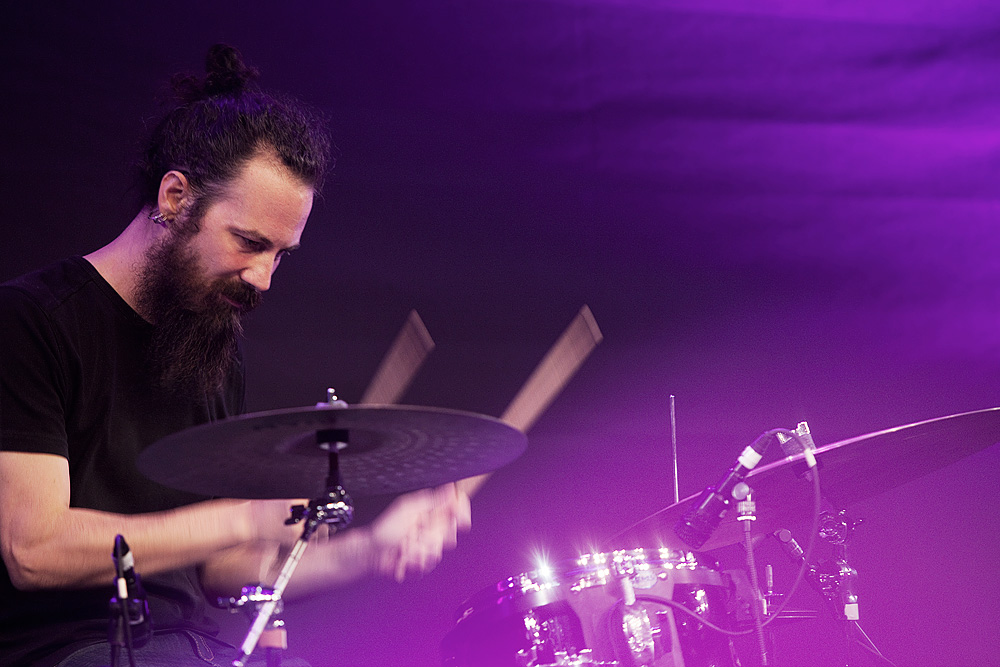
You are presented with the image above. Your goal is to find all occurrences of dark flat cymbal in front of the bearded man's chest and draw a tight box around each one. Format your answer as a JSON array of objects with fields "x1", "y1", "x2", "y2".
[{"x1": 137, "y1": 405, "x2": 527, "y2": 498}]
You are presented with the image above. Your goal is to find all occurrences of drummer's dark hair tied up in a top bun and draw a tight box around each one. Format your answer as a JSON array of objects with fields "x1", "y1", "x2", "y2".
[{"x1": 139, "y1": 44, "x2": 330, "y2": 217}]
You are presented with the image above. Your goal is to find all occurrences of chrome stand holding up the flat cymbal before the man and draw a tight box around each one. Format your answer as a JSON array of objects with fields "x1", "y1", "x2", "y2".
[{"x1": 232, "y1": 430, "x2": 354, "y2": 667}]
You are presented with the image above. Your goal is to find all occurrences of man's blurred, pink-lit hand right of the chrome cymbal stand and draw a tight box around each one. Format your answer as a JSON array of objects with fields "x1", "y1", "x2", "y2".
[{"x1": 371, "y1": 484, "x2": 472, "y2": 581}]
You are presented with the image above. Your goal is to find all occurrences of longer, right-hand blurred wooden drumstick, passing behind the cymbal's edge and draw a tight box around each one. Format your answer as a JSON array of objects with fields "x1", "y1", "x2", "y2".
[{"x1": 457, "y1": 305, "x2": 604, "y2": 496}]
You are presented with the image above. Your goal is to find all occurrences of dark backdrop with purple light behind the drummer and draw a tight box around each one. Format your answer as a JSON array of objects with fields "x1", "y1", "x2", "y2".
[{"x1": 0, "y1": 0, "x2": 1000, "y2": 667}]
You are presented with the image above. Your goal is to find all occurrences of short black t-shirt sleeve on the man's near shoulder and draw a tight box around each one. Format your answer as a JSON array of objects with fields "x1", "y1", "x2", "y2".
[{"x1": 0, "y1": 287, "x2": 69, "y2": 458}]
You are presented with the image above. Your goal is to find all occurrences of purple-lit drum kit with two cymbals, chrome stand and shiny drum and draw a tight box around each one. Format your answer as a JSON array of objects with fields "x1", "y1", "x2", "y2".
[{"x1": 139, "y1": 400, "x2": 1000, "y2": 667}]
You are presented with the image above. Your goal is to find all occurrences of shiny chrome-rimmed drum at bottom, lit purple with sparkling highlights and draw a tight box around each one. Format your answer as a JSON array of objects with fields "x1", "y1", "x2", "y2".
[{"x1": 442, "y1": 548, "x2": 734, "y2": 667}]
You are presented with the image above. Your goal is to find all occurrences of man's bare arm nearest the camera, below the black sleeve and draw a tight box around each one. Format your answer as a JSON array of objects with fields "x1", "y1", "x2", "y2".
[{"x1": 0, "y1": 452, "x2": 295, "y2": 590}]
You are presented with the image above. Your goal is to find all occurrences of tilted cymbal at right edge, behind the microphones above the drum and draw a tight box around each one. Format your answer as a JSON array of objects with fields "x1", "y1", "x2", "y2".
[{"x1": 606, "y1": 408, "x2": 1000, "y2": 551}]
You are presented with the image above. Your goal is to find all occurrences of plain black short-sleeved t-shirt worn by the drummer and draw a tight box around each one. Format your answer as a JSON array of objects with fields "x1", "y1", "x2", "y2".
[{"x1": 0, "y1": 257, "x2": 243, "y2": 665}]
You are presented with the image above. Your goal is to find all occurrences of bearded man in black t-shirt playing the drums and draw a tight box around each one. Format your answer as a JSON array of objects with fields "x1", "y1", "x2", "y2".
[{"x1": 0, "y1": 46, "x2": 469, "y2": 666}]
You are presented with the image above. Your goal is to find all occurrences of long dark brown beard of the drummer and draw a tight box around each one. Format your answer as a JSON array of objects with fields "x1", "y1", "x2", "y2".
[{"x1": 136, "y1": 232, "x2": 260, "y2": 396}]
